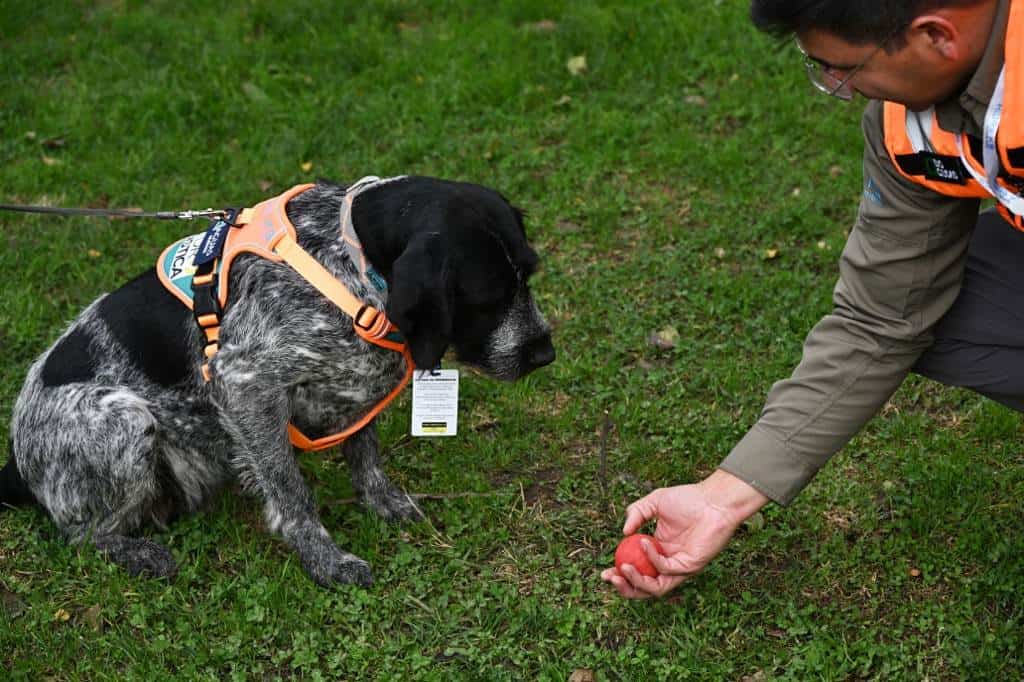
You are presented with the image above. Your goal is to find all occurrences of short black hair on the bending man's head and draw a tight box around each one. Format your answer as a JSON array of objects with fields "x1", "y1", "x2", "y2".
[{"x1": 751, "y1": 0, "x2": 981, "y2": 45}]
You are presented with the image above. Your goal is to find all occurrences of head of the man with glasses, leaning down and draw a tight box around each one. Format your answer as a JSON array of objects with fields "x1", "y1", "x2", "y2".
[{"x1": 751, "y1": 0, "x2": 997, "y2": 111}]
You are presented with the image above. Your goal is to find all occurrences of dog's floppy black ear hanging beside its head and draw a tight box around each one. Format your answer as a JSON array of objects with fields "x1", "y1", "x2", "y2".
[{"x1": 386, "y1": 232, "x2": 455, "y2": 370}]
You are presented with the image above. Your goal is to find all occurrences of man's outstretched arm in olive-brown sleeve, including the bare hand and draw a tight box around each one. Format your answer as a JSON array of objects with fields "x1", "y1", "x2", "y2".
[{"x1": 601, "y1": 102, "x2": 978, "y2": 598}]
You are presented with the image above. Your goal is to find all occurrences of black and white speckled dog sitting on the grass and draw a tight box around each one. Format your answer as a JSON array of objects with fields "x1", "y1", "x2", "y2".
[{"x1": 0, "y1": 176, "x2": 554, "y2": 586}]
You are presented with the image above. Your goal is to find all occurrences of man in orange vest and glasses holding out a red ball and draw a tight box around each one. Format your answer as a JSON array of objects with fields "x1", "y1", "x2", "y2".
[{"x1": 601, "y1": 0, "x2": 1024, "y2": 599}]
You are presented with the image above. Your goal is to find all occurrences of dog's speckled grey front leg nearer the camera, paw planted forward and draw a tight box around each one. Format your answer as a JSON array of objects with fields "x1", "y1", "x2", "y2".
[{"x1": 214, "y1": 373, "x2": 373, "y2": 587}]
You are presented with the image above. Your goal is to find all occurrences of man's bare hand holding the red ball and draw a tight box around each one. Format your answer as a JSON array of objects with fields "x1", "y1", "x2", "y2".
[{"x1": 601, "y1": 469, "x2": 768, "y2": 599}]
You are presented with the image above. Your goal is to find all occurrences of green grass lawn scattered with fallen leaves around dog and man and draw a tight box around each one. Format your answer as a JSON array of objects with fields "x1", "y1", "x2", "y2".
[{"x1": 0, "y1": 0, "x2": 1024, "y2": 680}]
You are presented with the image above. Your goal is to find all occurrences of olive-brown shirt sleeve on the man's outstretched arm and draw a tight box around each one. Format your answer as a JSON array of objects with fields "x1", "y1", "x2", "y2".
[{"x1": 720, "y1": 102, "x2": 979, "y2": 504}]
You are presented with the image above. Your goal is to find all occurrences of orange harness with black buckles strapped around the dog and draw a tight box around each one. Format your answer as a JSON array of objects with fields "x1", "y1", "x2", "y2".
[{"x1": 157, "y1": 178, "x2": 415, "y2": 451}]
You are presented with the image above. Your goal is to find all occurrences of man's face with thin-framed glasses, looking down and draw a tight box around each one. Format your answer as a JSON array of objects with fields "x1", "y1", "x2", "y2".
[{"x1": 797, "y1": 30, "x2": 961, "y2": 111}]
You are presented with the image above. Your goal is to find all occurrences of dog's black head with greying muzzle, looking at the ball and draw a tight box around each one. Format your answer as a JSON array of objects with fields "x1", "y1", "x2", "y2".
[{"x1": 352, "y1": 177, "x2": 555, "y2": 380}]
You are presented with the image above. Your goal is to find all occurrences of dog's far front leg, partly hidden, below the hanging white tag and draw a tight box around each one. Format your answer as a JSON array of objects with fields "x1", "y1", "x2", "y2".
[{"x1": 341, "y1": 422, "x2": 424, "y2": 520}]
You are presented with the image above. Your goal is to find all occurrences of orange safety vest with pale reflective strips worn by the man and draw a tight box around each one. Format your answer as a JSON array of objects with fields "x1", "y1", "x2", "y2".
[{"x1": 884, "y1": 2, "x2": 1024, "y2": 230}]
